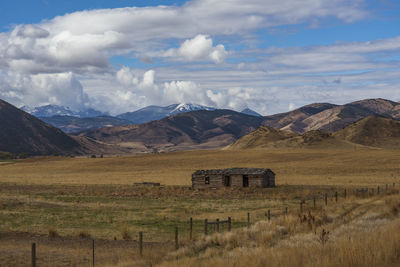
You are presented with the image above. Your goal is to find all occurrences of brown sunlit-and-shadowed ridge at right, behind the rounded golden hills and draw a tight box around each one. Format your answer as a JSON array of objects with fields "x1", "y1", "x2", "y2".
[{"x1": 263, "y1": 98, "x2": 400, "y2": 133}]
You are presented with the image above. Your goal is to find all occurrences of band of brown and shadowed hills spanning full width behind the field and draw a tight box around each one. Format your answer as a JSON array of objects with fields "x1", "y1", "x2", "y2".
[{"x1": 0, "y1": 99, "x2": 400, "y2": 155}]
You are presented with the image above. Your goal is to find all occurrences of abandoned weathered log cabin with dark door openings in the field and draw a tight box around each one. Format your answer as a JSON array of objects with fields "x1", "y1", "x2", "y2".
[{"x1": 192, "y1": 168, "x2": 275, "y2": 189}]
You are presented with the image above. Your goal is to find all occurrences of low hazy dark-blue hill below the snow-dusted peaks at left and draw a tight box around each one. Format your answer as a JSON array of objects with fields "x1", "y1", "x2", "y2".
[{"x1": 39, "y1": 116, "x2": 132, "y2": 133}]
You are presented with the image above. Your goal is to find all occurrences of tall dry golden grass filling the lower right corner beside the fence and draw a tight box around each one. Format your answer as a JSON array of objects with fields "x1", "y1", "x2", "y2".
[{"x1": 161, "y1": 195, "x2": 400, "y2": 267}]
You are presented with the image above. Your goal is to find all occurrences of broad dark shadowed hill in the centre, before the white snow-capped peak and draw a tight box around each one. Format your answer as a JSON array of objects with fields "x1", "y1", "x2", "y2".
[{"x1": 80, "y1": 109, "x2": 263, "y2": 151}]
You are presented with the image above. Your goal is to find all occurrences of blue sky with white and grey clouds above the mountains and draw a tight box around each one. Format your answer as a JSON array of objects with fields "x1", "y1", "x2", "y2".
[{"x1": 0, "y1": 0, "x2": 400, "y2": 115}]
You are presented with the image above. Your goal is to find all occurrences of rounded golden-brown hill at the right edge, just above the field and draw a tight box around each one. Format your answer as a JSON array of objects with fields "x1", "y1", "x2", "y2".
[{"x1": 334, "y1": 116, "x2": 400, "y2": 149}]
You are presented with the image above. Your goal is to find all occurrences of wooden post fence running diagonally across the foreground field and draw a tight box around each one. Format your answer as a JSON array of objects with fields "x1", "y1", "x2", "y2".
[{"x1": 27, "y1": 183, "x2": 398, "y2": 267}]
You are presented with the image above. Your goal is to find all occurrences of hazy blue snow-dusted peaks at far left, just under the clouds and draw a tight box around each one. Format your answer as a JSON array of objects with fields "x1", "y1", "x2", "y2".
[{"x1": 21, "y1": 105, "x2": 107, "y2": 118}]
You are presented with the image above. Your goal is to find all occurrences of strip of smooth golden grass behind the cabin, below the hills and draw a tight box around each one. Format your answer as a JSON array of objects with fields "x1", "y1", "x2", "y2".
[{"x1": 0, "y1": 150, "x2": 400, "y2": 185}]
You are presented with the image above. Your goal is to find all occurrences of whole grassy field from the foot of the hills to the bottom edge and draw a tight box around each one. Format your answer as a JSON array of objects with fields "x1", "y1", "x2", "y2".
[{"x1": 0, "y1": 150, "x2": 400, "y2": 266}]
